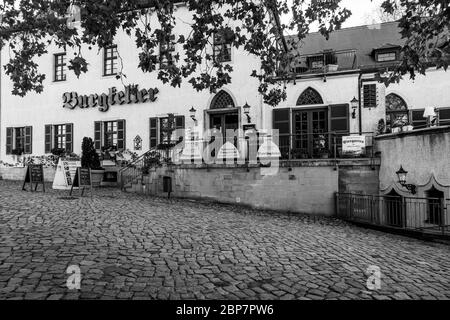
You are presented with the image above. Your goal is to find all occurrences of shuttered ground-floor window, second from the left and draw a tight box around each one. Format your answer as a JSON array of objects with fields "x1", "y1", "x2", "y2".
[{"x1": 45, "y1": 123, "x2": 73, "y2": 154}]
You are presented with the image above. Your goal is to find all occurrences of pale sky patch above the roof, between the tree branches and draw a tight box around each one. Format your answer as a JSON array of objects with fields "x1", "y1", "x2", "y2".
[{"x1": 284, "y1": 0, "x2": 383, "y2": 31}]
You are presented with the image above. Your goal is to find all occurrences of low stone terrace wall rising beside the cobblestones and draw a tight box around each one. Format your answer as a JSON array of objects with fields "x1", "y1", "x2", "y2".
[{"x1": 128, "y1": 160, "x2": 378, "y2": 216}]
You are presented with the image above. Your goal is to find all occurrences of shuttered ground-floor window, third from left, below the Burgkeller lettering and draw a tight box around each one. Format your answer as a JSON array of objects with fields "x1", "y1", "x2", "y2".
[{"x1": 94, "y1": 120, "x2": 125, "y2": 151}]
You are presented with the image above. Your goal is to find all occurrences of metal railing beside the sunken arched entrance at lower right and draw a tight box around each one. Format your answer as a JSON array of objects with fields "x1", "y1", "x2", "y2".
[{"x1": 336, "y1": 193, "x2": 450, "y2": 235}]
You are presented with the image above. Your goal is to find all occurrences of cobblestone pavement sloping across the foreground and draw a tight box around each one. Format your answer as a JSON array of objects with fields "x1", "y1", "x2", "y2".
[{"x1": 0, "y1": 181, "x2": 450, "y2": 299}]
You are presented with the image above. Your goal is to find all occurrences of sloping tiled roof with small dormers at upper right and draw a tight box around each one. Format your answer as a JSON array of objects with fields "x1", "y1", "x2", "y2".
[{"x1": 287, "y1": 22, "x2": 405, "y2": 68}]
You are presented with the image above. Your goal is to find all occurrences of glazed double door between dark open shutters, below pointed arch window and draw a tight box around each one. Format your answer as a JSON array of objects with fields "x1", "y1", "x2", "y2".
[{"x1": 293, "y1": 109, "x2": 329, "y2": 158}]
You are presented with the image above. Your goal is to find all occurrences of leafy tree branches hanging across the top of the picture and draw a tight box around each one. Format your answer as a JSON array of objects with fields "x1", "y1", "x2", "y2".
[{"x1": 0, "y1": 0, "x2": 450, "y2": 106}]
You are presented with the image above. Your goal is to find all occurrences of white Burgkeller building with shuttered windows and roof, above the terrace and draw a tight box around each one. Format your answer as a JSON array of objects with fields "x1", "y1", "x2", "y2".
[{"x1": 0, "y1": 11, "x2": 450, "y2": 163}]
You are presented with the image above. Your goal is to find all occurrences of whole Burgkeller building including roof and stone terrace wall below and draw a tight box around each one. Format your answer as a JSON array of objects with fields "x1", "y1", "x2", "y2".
[{"x1": 0, "y1": 4, "x2": 450, "y2": 218}]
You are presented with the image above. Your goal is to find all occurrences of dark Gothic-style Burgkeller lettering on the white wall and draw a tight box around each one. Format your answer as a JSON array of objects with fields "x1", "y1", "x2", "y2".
[{"x1": 63, "y1": 85, "x2": 159, "y2": 112}]
